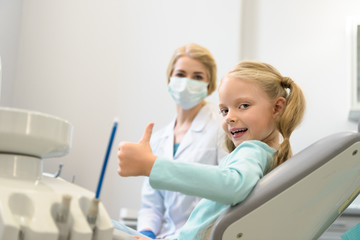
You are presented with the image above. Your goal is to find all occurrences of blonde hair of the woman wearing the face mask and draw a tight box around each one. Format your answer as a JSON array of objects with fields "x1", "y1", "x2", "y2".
[{"x1": 167, "y1": 43, "x2": 217, "y2": 96}]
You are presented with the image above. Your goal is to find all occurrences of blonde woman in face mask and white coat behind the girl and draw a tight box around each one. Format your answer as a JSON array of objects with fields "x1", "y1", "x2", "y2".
[{"x1": 137, "y1": 43, "x2": 226, "y2": 238}]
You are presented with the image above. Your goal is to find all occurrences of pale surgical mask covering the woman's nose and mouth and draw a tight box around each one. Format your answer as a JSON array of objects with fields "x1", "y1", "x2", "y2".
[{"x1": 168, "y1": 77, "x2": 208, "y2": 110}]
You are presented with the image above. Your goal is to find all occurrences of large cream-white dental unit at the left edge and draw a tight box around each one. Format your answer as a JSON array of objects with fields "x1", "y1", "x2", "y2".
[{"x1": 0, "y1": 107, "x2": 113, "y2": 240}]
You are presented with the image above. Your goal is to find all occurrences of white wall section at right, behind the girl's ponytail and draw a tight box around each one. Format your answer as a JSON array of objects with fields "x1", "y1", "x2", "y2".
[{"x1": 242, "y1": 0, "x2": 360, "y2": 152}]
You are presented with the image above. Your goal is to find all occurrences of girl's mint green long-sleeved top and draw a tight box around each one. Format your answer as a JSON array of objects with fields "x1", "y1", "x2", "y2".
[{"x1": 149, "y1": 140, "x2": 276, "y2": 240}]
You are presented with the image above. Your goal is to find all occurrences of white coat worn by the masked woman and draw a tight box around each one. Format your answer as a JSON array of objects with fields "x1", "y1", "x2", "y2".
[{"x1": 137, "y1": 103, "x2": 227, "y2": 238}]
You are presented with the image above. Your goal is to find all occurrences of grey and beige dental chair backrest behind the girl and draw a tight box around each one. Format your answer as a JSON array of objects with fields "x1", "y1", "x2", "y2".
[{"x1": 210, "y1": 128, "x2": 360, "y2": 240}]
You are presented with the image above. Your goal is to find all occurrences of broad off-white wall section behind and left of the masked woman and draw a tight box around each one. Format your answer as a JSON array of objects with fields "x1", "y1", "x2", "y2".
[{"x1": 12, "y1": 0, "x2": 241, "y2": 218}]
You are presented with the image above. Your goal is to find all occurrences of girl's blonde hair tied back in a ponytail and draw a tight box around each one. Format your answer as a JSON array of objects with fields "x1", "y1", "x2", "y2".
[{"x1": 225, "y1": 61, "x2": 305, "y2": 169}]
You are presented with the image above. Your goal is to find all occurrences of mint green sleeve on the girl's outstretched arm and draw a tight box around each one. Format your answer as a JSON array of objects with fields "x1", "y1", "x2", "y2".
[{"x1": 150, "y1": 142, "x2": 273, "y2": 204}]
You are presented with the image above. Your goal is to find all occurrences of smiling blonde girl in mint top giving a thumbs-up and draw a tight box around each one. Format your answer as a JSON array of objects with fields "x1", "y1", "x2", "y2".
[{"x1": 118, "y1": 62, "x2": 305, "y2": 240}]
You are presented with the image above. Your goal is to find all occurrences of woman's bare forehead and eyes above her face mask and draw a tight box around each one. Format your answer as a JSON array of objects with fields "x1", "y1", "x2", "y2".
[{"x1": 171, "y1": 56, "x2": 209, "y2": 83}]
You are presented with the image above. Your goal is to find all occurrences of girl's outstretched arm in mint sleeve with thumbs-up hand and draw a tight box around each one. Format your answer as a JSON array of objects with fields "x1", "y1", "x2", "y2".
[{"x1": 118, "y1": 123, "x2": 274, "y2": 204}]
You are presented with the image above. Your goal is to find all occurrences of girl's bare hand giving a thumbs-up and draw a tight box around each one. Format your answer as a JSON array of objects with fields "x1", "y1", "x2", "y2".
[{"x1": 117, "y1": 123, "x2": 156, "y2": 177}]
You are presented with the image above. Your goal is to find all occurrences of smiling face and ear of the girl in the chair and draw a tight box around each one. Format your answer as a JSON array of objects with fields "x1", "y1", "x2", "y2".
[{"x1": 219, "y1": 77, "x2": 286, "y2": 148}]
